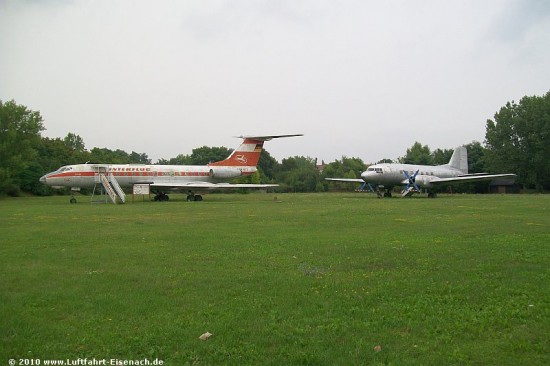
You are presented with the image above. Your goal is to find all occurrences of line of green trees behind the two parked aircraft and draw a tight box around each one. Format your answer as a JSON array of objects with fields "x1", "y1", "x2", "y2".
[{"x1": 0, "y1": 92, "x2": 550, "y2": 196}]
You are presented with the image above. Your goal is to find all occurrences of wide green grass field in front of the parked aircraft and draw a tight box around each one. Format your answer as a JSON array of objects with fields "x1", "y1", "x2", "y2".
[{"x1": 0, "y1": 193, "x2": 550, "y2": 365}]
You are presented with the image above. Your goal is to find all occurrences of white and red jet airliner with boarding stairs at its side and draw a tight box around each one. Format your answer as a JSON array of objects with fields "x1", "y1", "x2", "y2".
[{"x1": 40, "y1": 134, "x2": 303, "y2": 203}]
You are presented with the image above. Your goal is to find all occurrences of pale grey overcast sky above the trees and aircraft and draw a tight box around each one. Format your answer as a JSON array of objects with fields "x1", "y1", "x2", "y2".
[{"x1": 0, "y1": 0, "x2": 550, "y2": 163}]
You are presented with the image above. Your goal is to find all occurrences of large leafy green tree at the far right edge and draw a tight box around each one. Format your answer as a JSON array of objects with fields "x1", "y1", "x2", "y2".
[{"x1": 485, "y1": 91, "x2": 550, "y2": 190}]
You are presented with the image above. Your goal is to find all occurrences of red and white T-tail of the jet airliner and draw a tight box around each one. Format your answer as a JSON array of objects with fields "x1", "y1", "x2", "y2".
[{"x1": 208, "y1": 134, "x2": 303, "y2": 167}]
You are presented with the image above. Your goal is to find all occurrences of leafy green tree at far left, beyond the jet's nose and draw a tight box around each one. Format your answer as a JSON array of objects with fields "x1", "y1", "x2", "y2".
[{"x1": 0, "y1": 100, "x2": 44, "y2": 195}]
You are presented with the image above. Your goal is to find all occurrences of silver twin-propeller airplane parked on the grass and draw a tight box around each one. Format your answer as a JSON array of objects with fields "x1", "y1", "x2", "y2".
[{"x1": 326, "y1": 147, "x2": 516, "y2": 197}]
